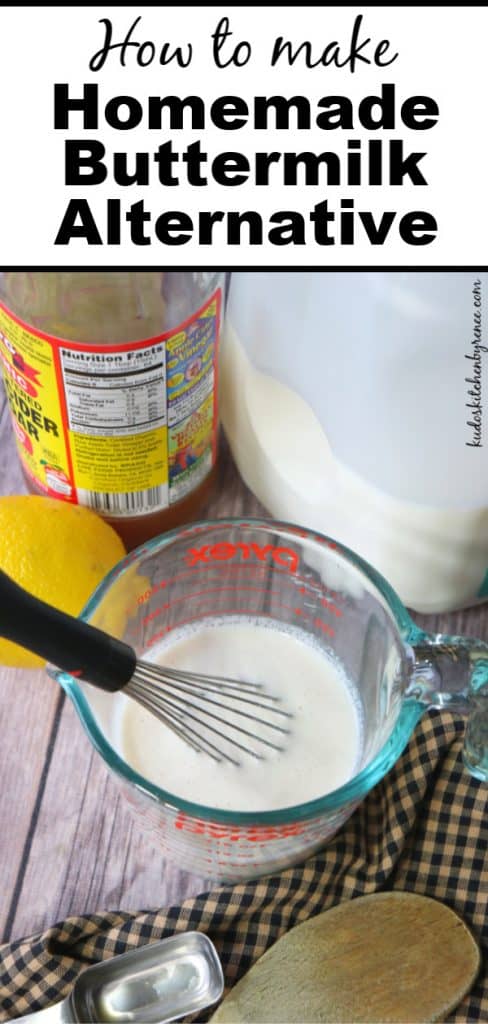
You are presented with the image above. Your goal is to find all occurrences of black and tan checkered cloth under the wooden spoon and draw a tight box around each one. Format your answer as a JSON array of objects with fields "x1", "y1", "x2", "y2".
[{"x1": 0, "y1": 713, "x2": 488, "y2": 1024}]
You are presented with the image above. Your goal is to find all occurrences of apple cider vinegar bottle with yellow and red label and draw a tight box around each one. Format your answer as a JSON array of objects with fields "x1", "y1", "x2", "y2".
[{"x1": 0, "y1": 270, "x2": 224, "y2": 548}]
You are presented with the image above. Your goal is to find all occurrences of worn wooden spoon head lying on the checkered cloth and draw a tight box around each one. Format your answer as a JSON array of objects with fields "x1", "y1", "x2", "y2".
[{"x1": 211, "y1": 892, "x2": 481, "y2": 1024}]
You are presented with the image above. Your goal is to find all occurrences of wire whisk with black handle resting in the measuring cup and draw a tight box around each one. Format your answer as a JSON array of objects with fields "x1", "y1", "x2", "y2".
[{"x1": 0, "y1": 570, "x2": 293, "y2": 765}]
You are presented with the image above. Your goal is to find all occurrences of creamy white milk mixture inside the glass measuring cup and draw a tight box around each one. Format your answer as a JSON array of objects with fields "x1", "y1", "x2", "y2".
[{"x1": 118, "y1": 616, "x2": 362, "y2": 811}]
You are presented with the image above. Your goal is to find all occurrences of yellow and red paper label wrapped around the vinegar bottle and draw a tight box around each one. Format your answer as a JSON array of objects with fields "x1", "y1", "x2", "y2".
[{"x1": 0, "y1": 289, "x2": 221, "y2": 516}]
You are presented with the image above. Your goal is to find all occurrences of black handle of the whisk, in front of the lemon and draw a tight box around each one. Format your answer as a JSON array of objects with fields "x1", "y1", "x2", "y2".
[{"x1": 0, "y1": 569, "x2": 136, "y2": 693}]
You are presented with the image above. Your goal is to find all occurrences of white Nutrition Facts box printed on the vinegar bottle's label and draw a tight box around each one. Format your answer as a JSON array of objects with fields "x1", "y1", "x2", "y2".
[{"x1": 59, "y1": 342, "x2": 167, "y2": 437}]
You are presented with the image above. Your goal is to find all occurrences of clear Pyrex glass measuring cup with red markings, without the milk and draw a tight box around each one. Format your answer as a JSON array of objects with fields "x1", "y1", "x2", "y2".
[{"x1": 56, "y1": 519, "x2": 488, "y2": 882}]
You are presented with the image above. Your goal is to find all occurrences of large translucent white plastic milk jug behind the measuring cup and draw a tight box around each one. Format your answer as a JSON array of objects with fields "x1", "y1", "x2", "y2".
[{"x1": 222, "y1": 271, "x2": 488, "y2": 612}]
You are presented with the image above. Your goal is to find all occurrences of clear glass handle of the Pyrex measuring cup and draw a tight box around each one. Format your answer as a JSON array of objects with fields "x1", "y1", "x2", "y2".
[{"x1": 405, "y1": 634, "x2": 488, "y2": 782}]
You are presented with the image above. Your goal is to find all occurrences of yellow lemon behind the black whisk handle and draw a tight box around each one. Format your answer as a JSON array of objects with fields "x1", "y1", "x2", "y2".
[{"x1": 0, "y1": 495, "x2": 125, "y2": 669}]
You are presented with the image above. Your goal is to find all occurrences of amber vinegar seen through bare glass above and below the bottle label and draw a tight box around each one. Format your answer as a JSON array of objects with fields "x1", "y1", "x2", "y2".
[{"x1": 0, "y1": 270, "x2": 224, "y2": 550}]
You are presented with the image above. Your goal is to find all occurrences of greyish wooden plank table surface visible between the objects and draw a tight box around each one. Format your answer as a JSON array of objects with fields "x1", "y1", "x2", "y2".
[{"x1": 0, "y1": 385, "x2": 488, "y2": 941}]
